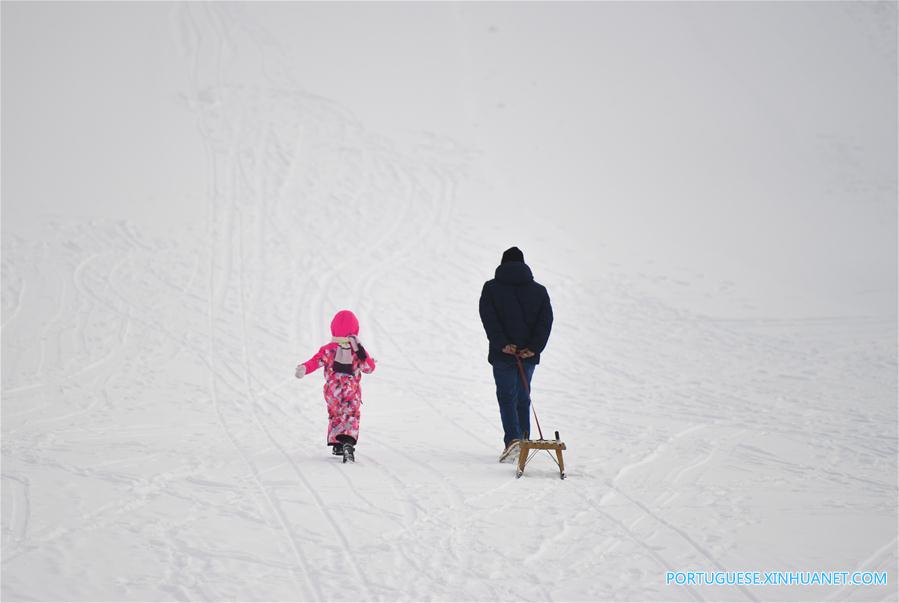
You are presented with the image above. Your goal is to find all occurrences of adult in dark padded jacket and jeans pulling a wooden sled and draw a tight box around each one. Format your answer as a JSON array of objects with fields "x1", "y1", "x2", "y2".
[{"x1": 480, "y1": 247, "x2": 553, "y2": 460}]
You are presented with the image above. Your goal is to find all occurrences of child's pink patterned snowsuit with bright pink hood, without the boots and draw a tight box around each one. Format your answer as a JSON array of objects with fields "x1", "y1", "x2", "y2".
[{"x1": 302, "y1": 310, "x2": 375, "y2": 444}]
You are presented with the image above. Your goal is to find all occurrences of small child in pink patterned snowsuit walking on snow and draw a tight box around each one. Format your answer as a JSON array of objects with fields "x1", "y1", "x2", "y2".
[{"x1": 296, "y1": 310, "x2": 375, "y2": 462}]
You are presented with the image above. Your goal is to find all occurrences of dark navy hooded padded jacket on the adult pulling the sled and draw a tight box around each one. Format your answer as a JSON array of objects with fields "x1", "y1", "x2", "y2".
[{"x1": 480, "y1": 262, "x2": 553, "y2": 364}]
